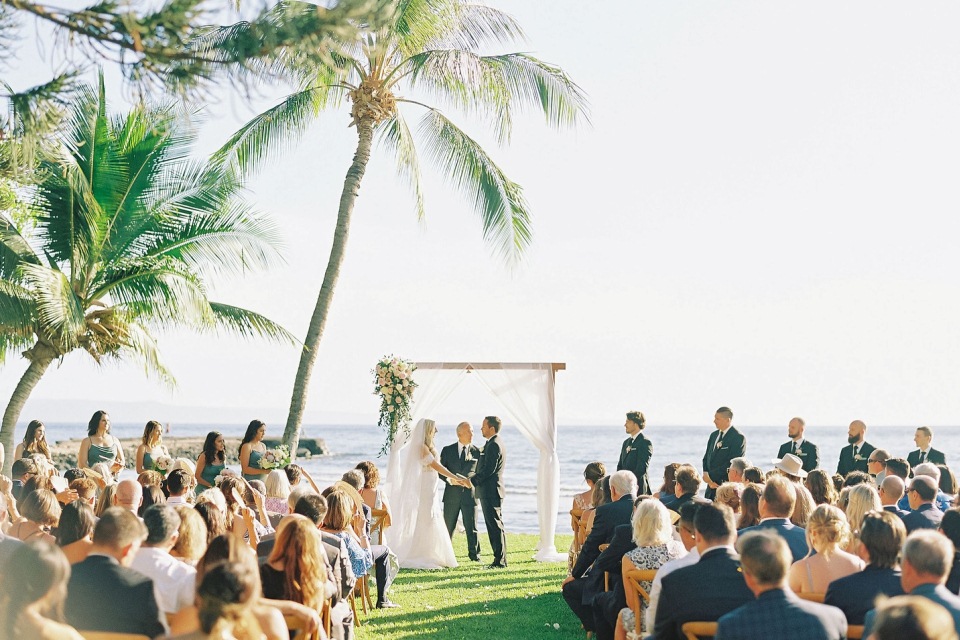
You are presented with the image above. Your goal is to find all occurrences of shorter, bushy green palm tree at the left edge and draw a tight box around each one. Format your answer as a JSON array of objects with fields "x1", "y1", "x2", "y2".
[{"x1": 0, "y1": 78, "x2": 292, "y2": 471}]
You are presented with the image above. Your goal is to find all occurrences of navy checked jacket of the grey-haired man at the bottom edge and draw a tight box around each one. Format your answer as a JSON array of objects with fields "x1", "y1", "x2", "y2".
[{"x1": 714, "y1": 589, "x2": 847, "y2": 640}]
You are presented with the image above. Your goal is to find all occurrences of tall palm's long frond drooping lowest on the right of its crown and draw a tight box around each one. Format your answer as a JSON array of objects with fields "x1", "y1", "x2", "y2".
[{"x1": 419, "y1": 109, "x2": 531, "y2": 264}]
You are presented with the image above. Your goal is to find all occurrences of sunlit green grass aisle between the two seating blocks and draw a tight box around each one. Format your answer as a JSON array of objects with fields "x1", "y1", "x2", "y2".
[{"x1": 357, "y1": 531, "x2": 584, "y2": 640}]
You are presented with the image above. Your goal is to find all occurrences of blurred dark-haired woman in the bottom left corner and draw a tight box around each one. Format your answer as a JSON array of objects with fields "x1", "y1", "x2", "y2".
[{"x1": 0, "y1": 541, "x2": 83, "y2": 640}]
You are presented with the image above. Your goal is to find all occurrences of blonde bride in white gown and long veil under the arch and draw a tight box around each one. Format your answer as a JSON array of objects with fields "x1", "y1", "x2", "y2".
[{"x1": 390, "y1": 420, "x2": 470, "y2": 569}]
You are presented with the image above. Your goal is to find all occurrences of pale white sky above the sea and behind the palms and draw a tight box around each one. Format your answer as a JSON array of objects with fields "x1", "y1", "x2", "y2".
[{"x1": 0, "y1": 0, "x2": 960, "y2": 431}]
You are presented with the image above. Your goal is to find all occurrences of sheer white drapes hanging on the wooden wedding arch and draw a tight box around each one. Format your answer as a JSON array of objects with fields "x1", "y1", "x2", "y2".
[{"x1": 387, "y1": 363, "x2": 566, "y2": 562}]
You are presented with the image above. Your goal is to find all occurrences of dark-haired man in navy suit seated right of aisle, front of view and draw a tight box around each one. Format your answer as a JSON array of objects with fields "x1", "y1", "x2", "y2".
[{"x1": 654, "y1": 502, "x2": 752, "y2": 640}]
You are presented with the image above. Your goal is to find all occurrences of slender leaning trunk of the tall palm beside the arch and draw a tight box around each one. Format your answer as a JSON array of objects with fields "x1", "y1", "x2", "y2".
[{"x1": 283, "y1": 118, "x2": 374, "y2": 457}]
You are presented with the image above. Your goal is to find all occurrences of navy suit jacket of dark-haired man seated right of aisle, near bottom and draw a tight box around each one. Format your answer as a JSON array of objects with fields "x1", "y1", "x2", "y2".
[{"x1": 654, "y1": 547, "x2": 753, "y2": 640}]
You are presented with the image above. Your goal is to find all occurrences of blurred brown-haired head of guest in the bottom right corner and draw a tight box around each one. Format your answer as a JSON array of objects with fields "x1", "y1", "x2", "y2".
[{"x1": 871, "y1": 596, "x2": 957, "y2": 640}]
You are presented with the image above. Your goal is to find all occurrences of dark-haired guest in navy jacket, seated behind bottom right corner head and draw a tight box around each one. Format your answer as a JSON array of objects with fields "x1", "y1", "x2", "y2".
[{"x1": 824, "y1": 511, "x2": 907, "y2": 624}]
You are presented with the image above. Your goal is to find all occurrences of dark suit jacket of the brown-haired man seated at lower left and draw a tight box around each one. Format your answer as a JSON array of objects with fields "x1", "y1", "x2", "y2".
[{"x1": 63, "y1": 555, "x2": 167, "y2": 638}]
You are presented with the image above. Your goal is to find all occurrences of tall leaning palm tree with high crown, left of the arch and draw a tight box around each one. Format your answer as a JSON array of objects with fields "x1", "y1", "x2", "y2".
[{"x1": 220, "y1": 0, "x2": 586, "y2": 451}]
